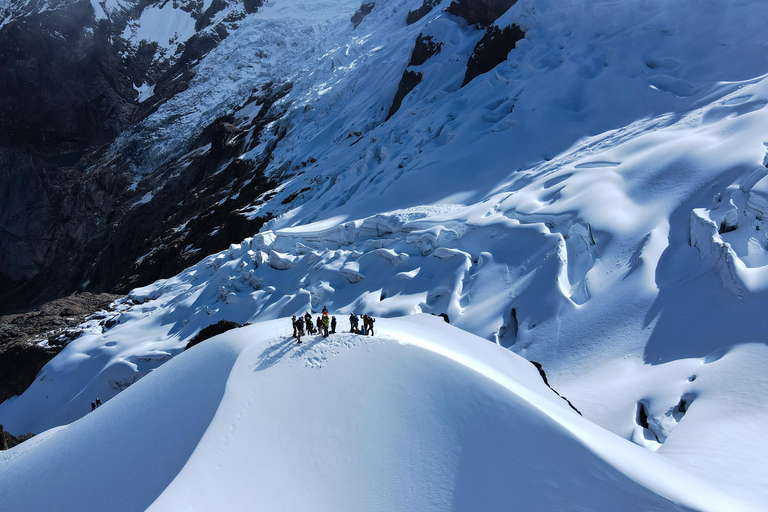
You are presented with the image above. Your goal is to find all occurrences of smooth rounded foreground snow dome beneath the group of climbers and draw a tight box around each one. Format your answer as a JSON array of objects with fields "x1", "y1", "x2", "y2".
[{"x1": 0, "y1": 315, "x2": 747, "y2": 512}]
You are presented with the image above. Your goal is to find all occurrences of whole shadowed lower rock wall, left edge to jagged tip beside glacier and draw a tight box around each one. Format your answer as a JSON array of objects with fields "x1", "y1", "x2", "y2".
[{"x1": 0, "y1": 71, "x2": 291, "y2": 312}]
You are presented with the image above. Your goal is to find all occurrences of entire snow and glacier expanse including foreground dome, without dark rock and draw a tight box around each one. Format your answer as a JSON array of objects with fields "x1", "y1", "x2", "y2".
[{"x1": 0, "y1": 0, "x2": 768, "y2": 511}]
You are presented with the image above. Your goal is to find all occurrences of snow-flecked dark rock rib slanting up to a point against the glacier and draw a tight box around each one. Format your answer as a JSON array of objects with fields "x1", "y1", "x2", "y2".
[{"x1": 97, "y1": 83, "x2": 291, "y2": 293}]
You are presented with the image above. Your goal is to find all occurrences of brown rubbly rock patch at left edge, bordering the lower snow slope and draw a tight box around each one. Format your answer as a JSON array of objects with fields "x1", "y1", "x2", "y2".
[{"x1": 0, "y1": 293, "x2": 120, "y2": 403}]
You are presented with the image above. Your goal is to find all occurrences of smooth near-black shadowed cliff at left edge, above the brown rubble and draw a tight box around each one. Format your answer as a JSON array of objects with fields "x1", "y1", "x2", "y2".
[{"x1": 0, "y1": 144, "x2": 135, "y2": 312}]
